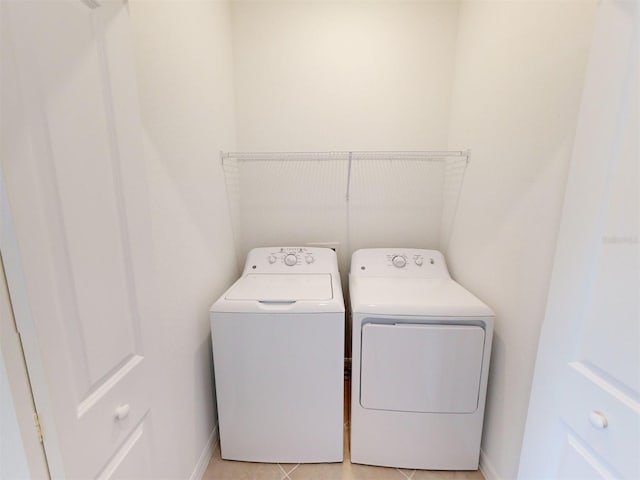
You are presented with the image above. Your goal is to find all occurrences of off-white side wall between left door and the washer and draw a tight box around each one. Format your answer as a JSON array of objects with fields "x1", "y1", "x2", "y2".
[{"x1": 130, "y1": 0, "x2": 237, "y2": 478}]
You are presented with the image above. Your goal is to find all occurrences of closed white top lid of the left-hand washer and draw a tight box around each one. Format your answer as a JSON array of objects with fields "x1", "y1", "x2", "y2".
[{"x1": 225, "y1": 273, "x2": 333, "y2": 302}]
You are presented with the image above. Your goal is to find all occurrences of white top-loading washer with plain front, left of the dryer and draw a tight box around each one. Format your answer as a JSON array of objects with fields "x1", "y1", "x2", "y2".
[{"x1": 210, "y1": 247, "x2": 345, "y2": 463}]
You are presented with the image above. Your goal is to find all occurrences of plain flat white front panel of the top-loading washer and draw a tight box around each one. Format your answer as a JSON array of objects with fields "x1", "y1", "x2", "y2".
[{"x1": 211, "y1": 313, "x2": 344, "y2": 463}]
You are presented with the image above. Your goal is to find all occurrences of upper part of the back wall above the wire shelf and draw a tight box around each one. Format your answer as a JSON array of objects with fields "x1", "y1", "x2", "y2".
[{"x1": 232, "y1": 0, "x2": 458, "y2": 151}]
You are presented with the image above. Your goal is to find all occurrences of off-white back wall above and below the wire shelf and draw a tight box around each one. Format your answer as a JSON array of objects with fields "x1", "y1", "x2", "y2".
[{"x1": 232, "y1": 0, "x2": 458, "y2": 278}]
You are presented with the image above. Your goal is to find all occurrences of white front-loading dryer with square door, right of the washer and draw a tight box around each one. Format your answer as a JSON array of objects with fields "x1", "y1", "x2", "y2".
[{"x1": 349, "y1": 248, "x2": 494, "y2": 470}]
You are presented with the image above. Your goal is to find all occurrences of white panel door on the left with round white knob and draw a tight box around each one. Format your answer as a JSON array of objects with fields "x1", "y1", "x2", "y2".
[{"x1": 1, "y1": 0, "x2": 151, "y2": 479}]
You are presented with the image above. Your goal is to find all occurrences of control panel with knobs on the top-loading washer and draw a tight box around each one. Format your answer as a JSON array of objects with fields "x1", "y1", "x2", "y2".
[{"x1": 244, "y1": 247, "x2": 338, "y2": 273}]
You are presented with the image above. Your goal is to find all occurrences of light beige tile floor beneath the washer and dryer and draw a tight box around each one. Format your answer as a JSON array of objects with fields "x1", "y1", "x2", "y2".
[{"x1": 202, "y1": 380, "x2": 484, "y2": 480}]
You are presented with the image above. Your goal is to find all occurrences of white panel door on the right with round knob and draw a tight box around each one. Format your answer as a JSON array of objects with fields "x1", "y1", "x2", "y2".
[{"x1": 519, "y1": 0, "x2": 640, "y2": 479}]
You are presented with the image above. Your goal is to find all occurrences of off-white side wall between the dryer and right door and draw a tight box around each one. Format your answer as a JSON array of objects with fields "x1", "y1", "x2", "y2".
[{"x1": 442, "y1": 1, "x2": 595, "y2": 479}]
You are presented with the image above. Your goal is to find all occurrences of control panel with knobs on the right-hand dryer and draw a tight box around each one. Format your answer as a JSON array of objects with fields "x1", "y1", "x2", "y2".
[{"x1": 351, "y1": 248, "x2": 451, "y2": 278}]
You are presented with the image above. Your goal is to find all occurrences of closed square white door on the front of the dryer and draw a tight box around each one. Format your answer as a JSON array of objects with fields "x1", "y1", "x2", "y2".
[{"x1": 360, "y1": 323, "x2": 485, "y2": 413}]
